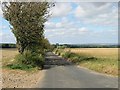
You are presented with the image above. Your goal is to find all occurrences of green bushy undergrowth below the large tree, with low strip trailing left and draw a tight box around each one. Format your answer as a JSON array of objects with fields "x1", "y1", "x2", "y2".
[{"x1": 7, "y1": 51, "x2": 44, "y2": 70}]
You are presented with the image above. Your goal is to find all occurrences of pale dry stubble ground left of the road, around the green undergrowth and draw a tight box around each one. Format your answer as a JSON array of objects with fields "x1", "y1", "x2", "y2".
[{"x1": 0, "y1": 49, "x2": 43, "y2": 88}]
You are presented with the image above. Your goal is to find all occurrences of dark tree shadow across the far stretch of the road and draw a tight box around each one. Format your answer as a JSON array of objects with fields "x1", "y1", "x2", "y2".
[{"x1": 43, "y1": 52, "x2": 73, "y2": 69}]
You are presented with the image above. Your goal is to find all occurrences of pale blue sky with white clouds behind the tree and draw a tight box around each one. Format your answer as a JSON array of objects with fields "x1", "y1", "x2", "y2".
[{"x1": 0, "y1": 2, "x2": 118, "y2": 44}]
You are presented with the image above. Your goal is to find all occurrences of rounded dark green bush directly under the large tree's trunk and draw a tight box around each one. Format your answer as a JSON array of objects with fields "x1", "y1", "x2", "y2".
[{"x1": 16, "y1": 51, "x2": 44, "y2": 67}]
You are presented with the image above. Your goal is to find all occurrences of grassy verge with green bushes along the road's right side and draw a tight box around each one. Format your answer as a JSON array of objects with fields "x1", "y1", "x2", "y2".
[{"x1": 54, "y1": 49, "x2": 118, "y2": 76}]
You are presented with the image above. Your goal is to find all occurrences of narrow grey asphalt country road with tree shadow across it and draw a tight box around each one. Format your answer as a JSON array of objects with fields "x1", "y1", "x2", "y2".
[{"x1": 37, "y1": 52, "x2": 118, "y2": 88}]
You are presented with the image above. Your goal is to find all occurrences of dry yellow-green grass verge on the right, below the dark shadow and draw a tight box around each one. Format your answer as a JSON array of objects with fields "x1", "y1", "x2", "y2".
[{"x1": 79, "y1": 58, "x2": 118, "y2": 76}]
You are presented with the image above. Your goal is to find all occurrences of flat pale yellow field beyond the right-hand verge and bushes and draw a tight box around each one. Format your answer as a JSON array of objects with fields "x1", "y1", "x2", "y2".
[{"x1": 67, "y1": 48, "x2": 118, "y2": 58}]
